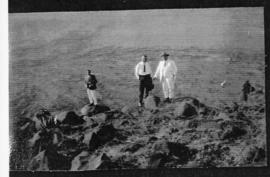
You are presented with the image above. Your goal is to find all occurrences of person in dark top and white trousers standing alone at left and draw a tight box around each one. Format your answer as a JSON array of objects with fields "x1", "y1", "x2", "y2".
[{"x1": 85, "y1": 70, "x2": 97, "y2": 105}]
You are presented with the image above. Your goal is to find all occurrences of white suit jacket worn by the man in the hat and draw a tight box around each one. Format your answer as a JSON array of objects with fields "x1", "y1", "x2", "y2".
[{"x1": 154, "y1": 59, "x2": 177, "y2": 80}]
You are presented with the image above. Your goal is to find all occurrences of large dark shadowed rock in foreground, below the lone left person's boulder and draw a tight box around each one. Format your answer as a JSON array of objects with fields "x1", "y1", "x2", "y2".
[{"x1": 89, "y1": 124, "x2": 116, "y2": 151}]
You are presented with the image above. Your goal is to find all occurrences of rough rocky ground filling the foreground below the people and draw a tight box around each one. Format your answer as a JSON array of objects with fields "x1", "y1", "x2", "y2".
[{"x1": 14, "y1": 92, "x2": 266, "y2": 170}]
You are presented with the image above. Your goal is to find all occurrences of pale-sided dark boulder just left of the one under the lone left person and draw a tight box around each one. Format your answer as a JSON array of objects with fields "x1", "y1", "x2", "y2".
[{"x1": 55, "y1": 111, "x2": 85, "y2": 125}]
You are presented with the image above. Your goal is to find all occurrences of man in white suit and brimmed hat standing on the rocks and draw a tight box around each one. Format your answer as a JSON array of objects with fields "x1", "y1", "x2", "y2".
[{"x1": 154, "y1": 53, "x2": 177, "y2": 103}]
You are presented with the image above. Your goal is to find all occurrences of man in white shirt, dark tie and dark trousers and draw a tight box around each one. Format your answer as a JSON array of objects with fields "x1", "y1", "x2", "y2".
[{"x1": 135, "y1": 55, "x2": 153, "y2": 106}]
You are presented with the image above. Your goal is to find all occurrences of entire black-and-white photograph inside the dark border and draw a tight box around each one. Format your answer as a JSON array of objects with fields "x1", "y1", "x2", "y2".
[{"x1": 8, "y1": 0, "x2": 268, "y2": 174}]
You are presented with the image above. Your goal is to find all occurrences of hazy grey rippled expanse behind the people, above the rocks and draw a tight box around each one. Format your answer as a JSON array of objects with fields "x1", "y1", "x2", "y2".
[{"x1": 9, "y1": 8, "x2": 265, "y2": 169}]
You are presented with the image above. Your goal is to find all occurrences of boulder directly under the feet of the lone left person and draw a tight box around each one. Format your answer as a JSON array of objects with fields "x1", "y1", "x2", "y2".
[{"x1": 81, "y1": 104, "x2": 110, "y2": 116}]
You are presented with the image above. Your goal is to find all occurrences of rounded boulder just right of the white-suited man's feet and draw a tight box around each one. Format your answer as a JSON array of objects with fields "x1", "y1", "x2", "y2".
[{"x1": 174, "y1": 101, "x2": 198, "y2": 118}]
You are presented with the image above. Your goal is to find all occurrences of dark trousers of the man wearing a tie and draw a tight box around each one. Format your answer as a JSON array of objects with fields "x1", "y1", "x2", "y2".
[{"x1": 139, "y1": 74, "x2": 152, "y2": 103}]
